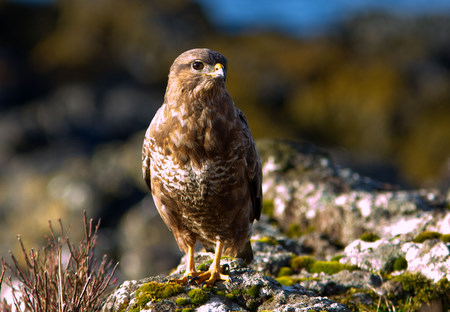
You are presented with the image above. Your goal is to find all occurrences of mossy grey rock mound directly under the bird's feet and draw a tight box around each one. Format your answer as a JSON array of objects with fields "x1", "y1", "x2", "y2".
[{"x1": 102, "y1": 253, "x2": 349, "y2": 312}]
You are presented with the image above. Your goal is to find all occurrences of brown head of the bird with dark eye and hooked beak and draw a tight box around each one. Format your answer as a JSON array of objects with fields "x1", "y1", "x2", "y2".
[{"x1": 168, "y1": 49, "x2": 227, "y2": 97}]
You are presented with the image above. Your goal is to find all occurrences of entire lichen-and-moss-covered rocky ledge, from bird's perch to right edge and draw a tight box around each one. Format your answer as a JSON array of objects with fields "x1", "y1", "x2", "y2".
[{"x1": 102, "y1": 141, "x2": 450, "y2": 312}]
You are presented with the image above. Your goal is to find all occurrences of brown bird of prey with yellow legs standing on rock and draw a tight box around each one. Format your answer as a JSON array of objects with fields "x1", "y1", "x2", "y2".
[{"x1": 142, "y1": 49, "x2": 262, "y2": 286}]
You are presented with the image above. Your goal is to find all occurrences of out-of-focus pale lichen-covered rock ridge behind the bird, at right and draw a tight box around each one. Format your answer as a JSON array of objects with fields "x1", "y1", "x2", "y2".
[{"x1": 257, "y1": 140, "x2": 450, "y2": 245}]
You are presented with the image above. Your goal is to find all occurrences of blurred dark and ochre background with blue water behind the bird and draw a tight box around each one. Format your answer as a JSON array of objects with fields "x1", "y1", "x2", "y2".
[{"x1": 0, "y1": 0, "x2": 450, "y2": 279}]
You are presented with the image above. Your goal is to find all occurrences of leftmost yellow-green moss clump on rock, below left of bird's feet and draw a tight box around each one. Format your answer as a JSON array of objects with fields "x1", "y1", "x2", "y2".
[{"x1": 130, "y1": 282, "x2": 183, "y2": 312}]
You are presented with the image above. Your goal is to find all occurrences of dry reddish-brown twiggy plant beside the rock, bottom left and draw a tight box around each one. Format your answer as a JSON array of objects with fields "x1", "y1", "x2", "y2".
[{"x1": 0, "y1": 213, "x2": 118, "y2": 312}]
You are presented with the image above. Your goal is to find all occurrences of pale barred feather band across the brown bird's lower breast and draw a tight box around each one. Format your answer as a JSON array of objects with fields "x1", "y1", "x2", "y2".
[{"x1": 152, "y1": 149, "x2": 238, "y2": 209}]
